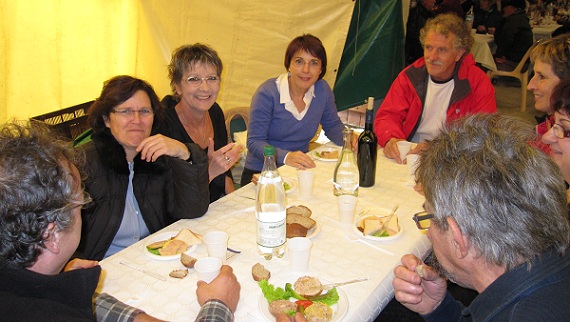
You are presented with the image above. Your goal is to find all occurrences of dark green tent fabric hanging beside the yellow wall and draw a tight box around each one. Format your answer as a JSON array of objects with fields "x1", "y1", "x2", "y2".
[{"x1": 333, "y1": 0, "x2": 404, "y2": 111}]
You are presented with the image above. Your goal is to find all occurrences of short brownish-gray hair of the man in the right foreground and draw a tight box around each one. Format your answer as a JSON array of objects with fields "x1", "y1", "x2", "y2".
[{"x1": 416, "y1": 114, "x2": 570, "y2": 269}]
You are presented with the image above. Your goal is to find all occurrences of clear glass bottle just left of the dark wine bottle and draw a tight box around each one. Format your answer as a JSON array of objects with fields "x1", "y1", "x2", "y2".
[{"x1": 333, "y1": 128, "x2": 359, "y2": 196}]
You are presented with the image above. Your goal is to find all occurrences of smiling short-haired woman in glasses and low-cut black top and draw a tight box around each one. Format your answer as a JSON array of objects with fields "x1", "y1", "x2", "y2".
[{"x1": 159, "y1": 44, "x2": 242, "y2": 202}]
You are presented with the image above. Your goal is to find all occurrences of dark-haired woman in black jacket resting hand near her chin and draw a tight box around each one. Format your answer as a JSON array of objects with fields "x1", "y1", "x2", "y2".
[{"x1": 79, "y1": 76, "x2": 209, "y2": 260}]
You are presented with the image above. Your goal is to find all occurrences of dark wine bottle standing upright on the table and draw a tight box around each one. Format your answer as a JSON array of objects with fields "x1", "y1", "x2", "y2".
[{"x1": 358, "y1": 97, "x2": 378, "y2": 187}]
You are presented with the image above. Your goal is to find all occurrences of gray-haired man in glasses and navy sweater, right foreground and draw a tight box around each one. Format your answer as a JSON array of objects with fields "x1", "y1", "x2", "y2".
[{"x1": 392, "y1": 114, "x2": 570, "y2": 322}]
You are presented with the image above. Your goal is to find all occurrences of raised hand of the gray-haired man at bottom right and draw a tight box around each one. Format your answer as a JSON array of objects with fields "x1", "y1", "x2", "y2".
[{"x1": 392, "y1": 254, "x2": 447, "y2": 314}]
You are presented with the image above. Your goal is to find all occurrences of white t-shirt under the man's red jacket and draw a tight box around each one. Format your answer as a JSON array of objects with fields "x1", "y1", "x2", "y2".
[{"x1": 411, "y1": 76, "x2": 455, "y2": 143}]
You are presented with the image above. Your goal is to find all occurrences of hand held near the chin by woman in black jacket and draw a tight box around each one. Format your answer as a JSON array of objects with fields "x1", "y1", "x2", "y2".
[{"x1": 136, "y1": 134, "x2": 190, "y2": 162}]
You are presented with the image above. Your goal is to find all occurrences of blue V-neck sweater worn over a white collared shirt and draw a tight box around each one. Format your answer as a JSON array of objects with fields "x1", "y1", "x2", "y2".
[{"x1": 245, "y1": 78, "x2": 344, "y2": 171}]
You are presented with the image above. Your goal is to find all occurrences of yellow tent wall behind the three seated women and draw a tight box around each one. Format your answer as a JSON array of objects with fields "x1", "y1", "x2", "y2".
[{"x1": 0, "y1": 0, "x2": 354, "y2": 122}]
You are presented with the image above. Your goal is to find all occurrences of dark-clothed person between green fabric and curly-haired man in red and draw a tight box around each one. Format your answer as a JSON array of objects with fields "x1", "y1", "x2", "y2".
[{"x1": 405, "y1": 0, "x2": 435, "y2": 65}]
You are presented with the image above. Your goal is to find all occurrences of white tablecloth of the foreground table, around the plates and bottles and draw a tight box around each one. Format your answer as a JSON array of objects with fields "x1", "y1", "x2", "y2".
[{"x1": 98, "y1": 145, "x2": 431, "y2": 322}]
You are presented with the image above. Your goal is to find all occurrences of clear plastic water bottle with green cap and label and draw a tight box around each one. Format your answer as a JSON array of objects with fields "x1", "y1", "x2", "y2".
[{"x1": 255, "y1": 145, "x2": 287, "y2": 260}]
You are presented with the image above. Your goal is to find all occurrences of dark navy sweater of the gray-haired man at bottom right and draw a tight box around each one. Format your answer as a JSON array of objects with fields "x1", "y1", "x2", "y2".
[{"x1": 423, "y1": 250, "x2": 570, "y2": 322}]
